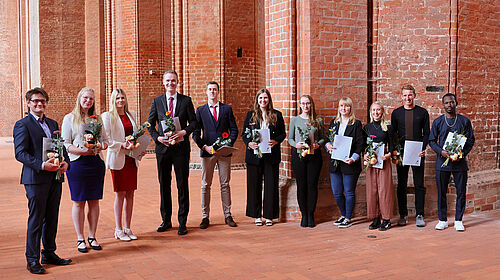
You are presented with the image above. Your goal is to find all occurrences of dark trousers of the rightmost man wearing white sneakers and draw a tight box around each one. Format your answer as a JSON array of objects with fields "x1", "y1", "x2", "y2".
[{"x1": 436, "y1": 170, "x2": 467, "y2": 221}]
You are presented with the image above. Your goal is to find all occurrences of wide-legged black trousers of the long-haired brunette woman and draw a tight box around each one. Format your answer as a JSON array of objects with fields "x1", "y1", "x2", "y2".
[{"x1": 246, "y1": 160, "x2": 280, "y2": 219}]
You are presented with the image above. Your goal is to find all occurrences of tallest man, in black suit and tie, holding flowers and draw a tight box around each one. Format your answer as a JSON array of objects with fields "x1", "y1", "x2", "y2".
[{"x1": 148, "y1": 70, "x2": 196, "y2": 235}]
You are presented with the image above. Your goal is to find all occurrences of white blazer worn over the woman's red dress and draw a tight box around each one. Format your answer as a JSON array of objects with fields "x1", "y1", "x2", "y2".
[{"x1": 101, "y1": 111, "x2": 139, "y2": 170}]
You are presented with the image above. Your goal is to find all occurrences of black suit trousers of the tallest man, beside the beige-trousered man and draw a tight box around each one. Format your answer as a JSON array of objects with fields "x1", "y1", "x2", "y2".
[{"x1": 156, "y1": 150, "x2": 189, "y2": 225}]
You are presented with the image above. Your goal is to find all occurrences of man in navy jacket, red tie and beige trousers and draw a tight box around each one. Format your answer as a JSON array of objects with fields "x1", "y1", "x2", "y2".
[{"x1": 193, "y1": 81, "x2": 238, "y2": 229}]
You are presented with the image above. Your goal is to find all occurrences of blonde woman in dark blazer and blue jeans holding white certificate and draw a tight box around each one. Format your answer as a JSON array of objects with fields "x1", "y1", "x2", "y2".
[{"x1": 325, "y1": 97, "x2": 363, "y2": 228}]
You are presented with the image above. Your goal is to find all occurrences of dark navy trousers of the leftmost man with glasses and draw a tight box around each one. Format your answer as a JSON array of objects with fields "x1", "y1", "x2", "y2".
[{"x1": 24, "y1": 181, "x2": 62, "y2": 262}]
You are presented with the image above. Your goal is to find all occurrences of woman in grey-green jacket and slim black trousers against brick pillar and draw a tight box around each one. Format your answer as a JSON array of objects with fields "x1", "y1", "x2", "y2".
[{"x1": 288, "y1": 95, "x2": 325, "y2": 227}]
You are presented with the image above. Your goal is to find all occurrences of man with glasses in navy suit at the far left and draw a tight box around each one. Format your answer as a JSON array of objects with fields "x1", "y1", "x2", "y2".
[{"x1": 14, "y1": 88, "x2": 71, "y2": 274}]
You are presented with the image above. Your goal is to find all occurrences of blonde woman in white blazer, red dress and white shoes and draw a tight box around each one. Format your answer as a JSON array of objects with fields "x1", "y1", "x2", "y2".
[{"x1": 101, "y1": 89, "x2": 139, "y2": 241}]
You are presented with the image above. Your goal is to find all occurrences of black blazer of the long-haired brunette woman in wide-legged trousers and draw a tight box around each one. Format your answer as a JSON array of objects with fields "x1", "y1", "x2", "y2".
[{"x1": 241, "y1": 110, "x2": 286, "y2": 165}]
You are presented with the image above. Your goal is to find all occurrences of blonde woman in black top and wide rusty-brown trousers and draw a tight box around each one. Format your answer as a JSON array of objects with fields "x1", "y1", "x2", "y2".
[{"x1": 364, "y1": 101, "x2": 394, "y2": 231}]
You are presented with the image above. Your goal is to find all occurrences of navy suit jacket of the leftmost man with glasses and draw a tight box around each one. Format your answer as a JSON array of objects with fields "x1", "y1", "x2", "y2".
[{"x1": 13, "y1": 114, "x2": 69, "y2": 185}]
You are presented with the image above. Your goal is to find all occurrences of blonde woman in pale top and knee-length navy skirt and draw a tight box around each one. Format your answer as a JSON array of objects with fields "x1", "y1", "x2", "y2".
[{"x1": 61, "y1": 88, "x2": 107, "y2": 253}]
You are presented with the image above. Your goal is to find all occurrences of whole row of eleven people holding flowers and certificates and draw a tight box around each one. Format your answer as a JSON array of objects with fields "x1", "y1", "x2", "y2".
[{"x1": 14, "y1": 70, "x2": 474, "y2": 274}]
